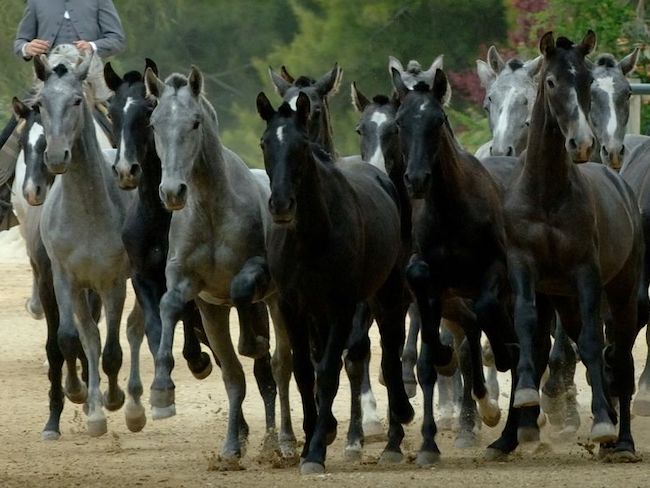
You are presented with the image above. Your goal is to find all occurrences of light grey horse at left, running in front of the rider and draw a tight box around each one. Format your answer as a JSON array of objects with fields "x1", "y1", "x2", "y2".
[{"x1": 34, "y1": 56, "x2": 144, "y2": 436}]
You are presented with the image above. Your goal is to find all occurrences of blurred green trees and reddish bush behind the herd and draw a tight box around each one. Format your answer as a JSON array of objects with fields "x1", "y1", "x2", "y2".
[{"x1": 0, "y1": 0, "x2": 650, "y2": 166}]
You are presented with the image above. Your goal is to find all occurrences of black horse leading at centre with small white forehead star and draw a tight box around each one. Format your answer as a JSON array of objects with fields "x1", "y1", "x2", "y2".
[{"x1": 257, "y1": 93, "x2": 414, "y2": 474}]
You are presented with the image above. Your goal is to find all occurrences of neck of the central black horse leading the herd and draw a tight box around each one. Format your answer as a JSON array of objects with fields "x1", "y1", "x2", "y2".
[{"x1": 296, "y1": 153, "x2": 335, "y2": 242}]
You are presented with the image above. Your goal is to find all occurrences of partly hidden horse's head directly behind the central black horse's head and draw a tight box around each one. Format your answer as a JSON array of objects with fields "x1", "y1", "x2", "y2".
[{"x1": 269, "y1": 64, "x2": 343, "y2": 150}]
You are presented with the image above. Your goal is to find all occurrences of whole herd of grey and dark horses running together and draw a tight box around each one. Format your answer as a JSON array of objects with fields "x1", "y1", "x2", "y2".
[{"x1": 3, "y1": 31, "x2": 650, "y2": 474}]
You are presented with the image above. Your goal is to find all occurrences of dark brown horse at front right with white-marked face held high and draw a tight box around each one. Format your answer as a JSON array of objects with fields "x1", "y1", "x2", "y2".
[{"x1": 504, "y1": 31, "x2": 643, "y2": 459}]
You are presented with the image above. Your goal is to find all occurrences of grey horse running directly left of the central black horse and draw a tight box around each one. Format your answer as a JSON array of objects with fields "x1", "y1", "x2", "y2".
[{"x1": 145, "y1": 67, "x2": 295, "y2": 460}]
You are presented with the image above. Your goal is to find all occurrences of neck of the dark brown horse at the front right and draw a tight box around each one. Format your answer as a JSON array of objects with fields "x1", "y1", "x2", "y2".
[{"x1": 519, "y1": 85, "x2": 572, "y2": 201}]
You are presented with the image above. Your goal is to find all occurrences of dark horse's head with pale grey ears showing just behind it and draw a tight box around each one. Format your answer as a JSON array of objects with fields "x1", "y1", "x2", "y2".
[{"x1": 392, "y1": 69, "x2": 447, "y2": 198}]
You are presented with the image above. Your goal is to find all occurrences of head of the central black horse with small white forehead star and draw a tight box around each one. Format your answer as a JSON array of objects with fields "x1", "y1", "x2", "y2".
[{"x1": 257, "y1": 92, "x2": 312, "y2": 225}]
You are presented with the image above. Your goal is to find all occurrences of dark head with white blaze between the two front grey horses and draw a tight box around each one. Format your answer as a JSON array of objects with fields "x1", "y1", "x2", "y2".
[{"x1": 104, "y1": 58, "x2": 158, "y2": 190}]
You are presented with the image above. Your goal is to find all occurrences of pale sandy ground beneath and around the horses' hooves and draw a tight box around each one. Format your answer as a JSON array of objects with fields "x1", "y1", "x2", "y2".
[{"x1": 0, "y1": 229, "x2": 650, "y2": 488}]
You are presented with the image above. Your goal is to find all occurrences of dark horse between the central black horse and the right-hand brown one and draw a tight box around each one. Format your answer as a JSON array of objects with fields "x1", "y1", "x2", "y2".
[{"x1": 392, "y1": 70, "x2": 536, "y2": 459}]
